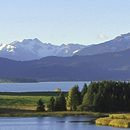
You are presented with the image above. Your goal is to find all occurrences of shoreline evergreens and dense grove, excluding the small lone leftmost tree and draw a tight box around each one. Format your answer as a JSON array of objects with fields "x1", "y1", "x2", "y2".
[{"x1": 35, "y1": 80, "x2": 130, "y2": 112}]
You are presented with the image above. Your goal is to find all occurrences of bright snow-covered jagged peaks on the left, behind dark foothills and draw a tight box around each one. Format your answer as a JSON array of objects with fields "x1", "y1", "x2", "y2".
[{"x1": 0, "y1": 38, "x2": 86, "y2": 61}]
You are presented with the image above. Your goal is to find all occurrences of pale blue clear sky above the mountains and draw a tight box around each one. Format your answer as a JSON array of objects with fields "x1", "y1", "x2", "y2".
[{"x1": 0, "y1": 0, "x2": 130, "y2": 45}]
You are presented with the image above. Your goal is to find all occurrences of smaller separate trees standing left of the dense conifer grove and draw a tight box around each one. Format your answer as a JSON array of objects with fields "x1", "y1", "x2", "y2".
[{"x1": 36, "y1": 83, "x2": 87, "y2": 111}]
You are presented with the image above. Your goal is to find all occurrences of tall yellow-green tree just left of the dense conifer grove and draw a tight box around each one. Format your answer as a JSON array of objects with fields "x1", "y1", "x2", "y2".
[{"x1": 68, "y1": 85, "x2": 82, "y2": 111}]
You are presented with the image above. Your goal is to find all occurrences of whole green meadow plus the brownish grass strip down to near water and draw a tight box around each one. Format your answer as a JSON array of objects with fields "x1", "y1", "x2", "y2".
[{"x1": 0, "y1": 92, "x2": 106, "y2": 117}]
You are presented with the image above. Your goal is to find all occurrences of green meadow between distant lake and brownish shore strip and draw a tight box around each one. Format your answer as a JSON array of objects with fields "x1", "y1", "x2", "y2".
[{"x1": 0, "y1": 92, "x2": 67, "y2": 110}]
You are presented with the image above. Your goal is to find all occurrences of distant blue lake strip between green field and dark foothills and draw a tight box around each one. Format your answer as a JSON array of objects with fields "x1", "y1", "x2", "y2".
[{"x1": 0, "y1": 81, "x2": 90, "y2": 92}]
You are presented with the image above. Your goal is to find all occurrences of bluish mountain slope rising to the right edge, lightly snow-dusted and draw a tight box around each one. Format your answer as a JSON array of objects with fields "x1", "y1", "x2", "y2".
[{"x1": 76, "y1": 33, "x2": 130, "y2": 55}]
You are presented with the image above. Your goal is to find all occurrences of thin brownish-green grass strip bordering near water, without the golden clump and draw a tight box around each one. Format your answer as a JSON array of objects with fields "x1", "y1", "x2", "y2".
[{"x1": 0, "y1": 108, "x2": 108, "y2": 118}]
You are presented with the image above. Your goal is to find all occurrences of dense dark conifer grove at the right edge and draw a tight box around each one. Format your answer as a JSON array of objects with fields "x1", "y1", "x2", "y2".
[{"x1": 82, "y1": 81, "x2": 130, "y2": 112}]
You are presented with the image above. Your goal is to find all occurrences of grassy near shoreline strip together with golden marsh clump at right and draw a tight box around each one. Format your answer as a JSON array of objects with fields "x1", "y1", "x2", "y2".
[{"x1": 0, "y1": 108, "x2": 130, "y2": 128}]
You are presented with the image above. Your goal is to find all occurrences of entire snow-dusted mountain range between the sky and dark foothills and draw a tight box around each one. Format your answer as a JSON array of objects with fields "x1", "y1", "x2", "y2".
[{"x1": 0, "y1": 33, "x2": 130, "y2": 61}]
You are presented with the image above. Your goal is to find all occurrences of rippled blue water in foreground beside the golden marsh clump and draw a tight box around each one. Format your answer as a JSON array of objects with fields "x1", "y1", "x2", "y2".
[{"x1": 0, "y1": 117, "x2": 129, "y2": 130}]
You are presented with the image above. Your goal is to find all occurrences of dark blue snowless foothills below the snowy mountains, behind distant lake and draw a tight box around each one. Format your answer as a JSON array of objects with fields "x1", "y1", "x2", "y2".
[{"x1": 0, "y1": 49, "x2": 130, "y2": 81}]
